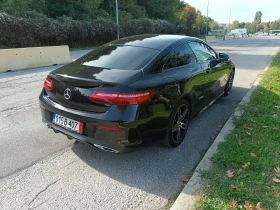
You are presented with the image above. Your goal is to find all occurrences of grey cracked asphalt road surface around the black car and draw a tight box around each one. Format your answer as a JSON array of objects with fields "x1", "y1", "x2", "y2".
[{"x1": 0, "y1": 37, "x2": 280, "y2": 210}]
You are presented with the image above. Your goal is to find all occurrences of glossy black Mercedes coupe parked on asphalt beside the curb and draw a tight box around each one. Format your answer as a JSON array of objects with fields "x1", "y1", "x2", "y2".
[{"x1": 39, "y1": 35, "x2": 235, "y2": 153}]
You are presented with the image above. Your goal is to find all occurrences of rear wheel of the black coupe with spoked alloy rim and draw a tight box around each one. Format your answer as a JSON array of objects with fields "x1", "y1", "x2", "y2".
[{"x1": 162, "y1": 100, "x2": 190, "y2": 147}]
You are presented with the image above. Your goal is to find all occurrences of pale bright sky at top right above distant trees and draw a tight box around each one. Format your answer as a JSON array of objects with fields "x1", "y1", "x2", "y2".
[{"x1": 184, "y1": 0, "x2": 280, "y2": 23}]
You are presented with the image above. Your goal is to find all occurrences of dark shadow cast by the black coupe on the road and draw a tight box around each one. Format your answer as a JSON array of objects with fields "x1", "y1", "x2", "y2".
[{"x1": 72, "y1": 87, "x2": 248, "y2": 198}]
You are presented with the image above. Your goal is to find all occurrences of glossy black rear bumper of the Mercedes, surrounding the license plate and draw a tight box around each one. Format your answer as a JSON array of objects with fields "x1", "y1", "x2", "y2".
[{"x1": 39, "y1": 90, "x2": 165, "y2": 153}]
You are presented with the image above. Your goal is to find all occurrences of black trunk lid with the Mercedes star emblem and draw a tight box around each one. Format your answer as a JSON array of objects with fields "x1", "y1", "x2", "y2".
[{"x1": 45, "y1": 63, "x2": 143, "y2": 113}]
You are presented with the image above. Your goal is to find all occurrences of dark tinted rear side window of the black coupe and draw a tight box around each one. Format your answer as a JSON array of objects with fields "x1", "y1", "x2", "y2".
[{"x1": 163, "y1": 43, "x2": 197, "y2": 70}]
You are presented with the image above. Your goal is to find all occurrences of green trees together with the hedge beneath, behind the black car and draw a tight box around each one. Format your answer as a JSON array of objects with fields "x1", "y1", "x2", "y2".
[{"x1": 0, "y1": 0, "x2": 218, "y2": 47}]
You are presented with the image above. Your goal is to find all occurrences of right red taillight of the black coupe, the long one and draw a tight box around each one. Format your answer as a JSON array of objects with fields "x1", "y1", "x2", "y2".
[{"x1": 90, "y1": 90, "x2": 155, "y2": 105}]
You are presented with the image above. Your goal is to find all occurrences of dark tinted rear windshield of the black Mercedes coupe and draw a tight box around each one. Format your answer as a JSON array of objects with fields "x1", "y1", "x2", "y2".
[{"x1": 76, "y1": 45, "x2": 159, "y2": 70}]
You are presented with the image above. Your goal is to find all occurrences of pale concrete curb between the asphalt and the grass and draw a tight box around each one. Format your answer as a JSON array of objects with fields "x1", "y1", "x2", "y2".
[{"x1": 170, "y1": 50, "x2": 278, "y2": 210}]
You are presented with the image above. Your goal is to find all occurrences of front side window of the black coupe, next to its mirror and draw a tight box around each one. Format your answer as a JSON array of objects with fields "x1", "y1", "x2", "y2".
[{"x1": 189, "y1": 42, "x2": 216, "y2": 62}]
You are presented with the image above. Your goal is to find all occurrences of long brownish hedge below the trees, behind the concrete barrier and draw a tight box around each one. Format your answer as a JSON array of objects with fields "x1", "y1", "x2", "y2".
[{"x1": 0, "y1": 12, "x2": 177, "y2": 48}]
